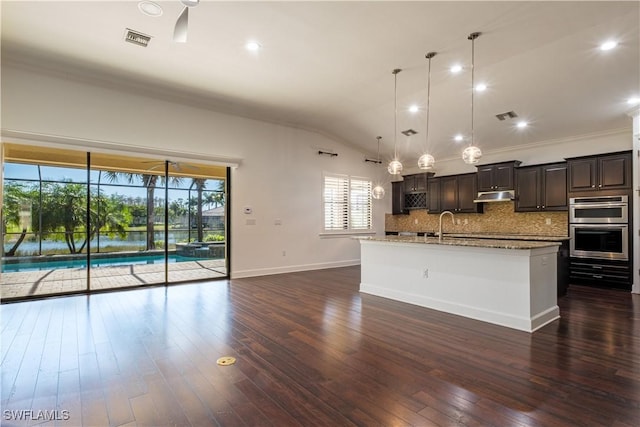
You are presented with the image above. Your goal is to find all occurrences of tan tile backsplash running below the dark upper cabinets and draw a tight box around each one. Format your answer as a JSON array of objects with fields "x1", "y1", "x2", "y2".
[{"x1": 385, "y1": 202, "x2": 569, "y2": 236}]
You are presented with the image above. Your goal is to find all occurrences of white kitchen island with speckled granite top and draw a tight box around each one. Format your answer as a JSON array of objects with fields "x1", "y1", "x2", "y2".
[{"x1": 359, "y1": 236, "x2": 560, "y2": 332}]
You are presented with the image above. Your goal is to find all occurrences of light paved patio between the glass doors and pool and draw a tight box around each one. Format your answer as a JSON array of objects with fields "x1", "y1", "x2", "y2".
[{"x1": 0, "y1": 259, "x2": 227, "y2": 300}]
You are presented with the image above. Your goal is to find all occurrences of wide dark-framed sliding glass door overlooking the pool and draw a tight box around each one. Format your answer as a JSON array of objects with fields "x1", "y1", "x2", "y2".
[{"x1": 0, "y1": 144, "x2": 227, "y2": 300}]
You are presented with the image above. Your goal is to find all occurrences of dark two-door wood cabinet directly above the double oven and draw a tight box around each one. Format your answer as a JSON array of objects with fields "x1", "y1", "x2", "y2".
[{"x1": 567, "y1": 151, "x2": 631, "y2": 192}]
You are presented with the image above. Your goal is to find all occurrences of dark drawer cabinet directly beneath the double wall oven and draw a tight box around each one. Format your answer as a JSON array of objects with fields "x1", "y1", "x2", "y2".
[{"x1": 569, "y1": 258, "x2": 632, "y2": 290}]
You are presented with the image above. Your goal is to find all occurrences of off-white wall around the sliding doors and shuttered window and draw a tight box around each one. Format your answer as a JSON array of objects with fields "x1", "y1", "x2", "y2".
[{"x1": 1, "y1": 66, "x2": 391, "y2": 277}]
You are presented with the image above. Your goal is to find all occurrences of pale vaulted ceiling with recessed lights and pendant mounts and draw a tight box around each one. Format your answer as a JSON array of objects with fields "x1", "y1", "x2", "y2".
[{"x1": 1, "y1": 0, "x2": 640, "y2": 163}]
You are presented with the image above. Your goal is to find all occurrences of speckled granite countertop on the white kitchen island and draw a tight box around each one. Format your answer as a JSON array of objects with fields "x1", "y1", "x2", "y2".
[{"x1": 356, "y1": 235, "x2": 560, "y2": 249}]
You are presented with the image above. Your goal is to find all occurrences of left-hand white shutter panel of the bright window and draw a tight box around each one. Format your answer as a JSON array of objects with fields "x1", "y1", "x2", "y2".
[{"x1": 323, "y1": 175, "x2": 349, "y2": 231}]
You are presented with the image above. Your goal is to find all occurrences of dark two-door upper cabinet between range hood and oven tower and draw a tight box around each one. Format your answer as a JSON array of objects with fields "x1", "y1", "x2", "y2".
[{"x1": 515, "y1": 162, "x2": 568, "y2": 212}]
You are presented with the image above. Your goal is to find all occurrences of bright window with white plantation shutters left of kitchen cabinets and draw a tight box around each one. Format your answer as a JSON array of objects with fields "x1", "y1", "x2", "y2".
[{"x1": 323, "y1": 174, "x2": 373, "y2": 232}]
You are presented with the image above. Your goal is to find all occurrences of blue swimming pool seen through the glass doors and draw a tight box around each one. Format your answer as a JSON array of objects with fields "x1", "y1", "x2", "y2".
[{"x1": 2, "y1": 254, "x2": 211, "y2": 273}]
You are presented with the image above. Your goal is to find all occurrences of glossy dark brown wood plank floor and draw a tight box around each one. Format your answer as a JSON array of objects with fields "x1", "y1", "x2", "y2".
[{"x1": 0, "y1": 267, "x2": 640, "y2": 426}]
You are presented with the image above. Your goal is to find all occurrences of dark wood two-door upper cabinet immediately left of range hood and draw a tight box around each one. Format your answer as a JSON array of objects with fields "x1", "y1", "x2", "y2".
[{"x1": 440, "y1": 173, "x2": 482, "y2": 213}]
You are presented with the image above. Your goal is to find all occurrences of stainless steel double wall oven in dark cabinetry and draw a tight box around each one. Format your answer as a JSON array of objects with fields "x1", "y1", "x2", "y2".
[{"x1": 569, "y1": 195, "x2": 629, "y2": 261}]
